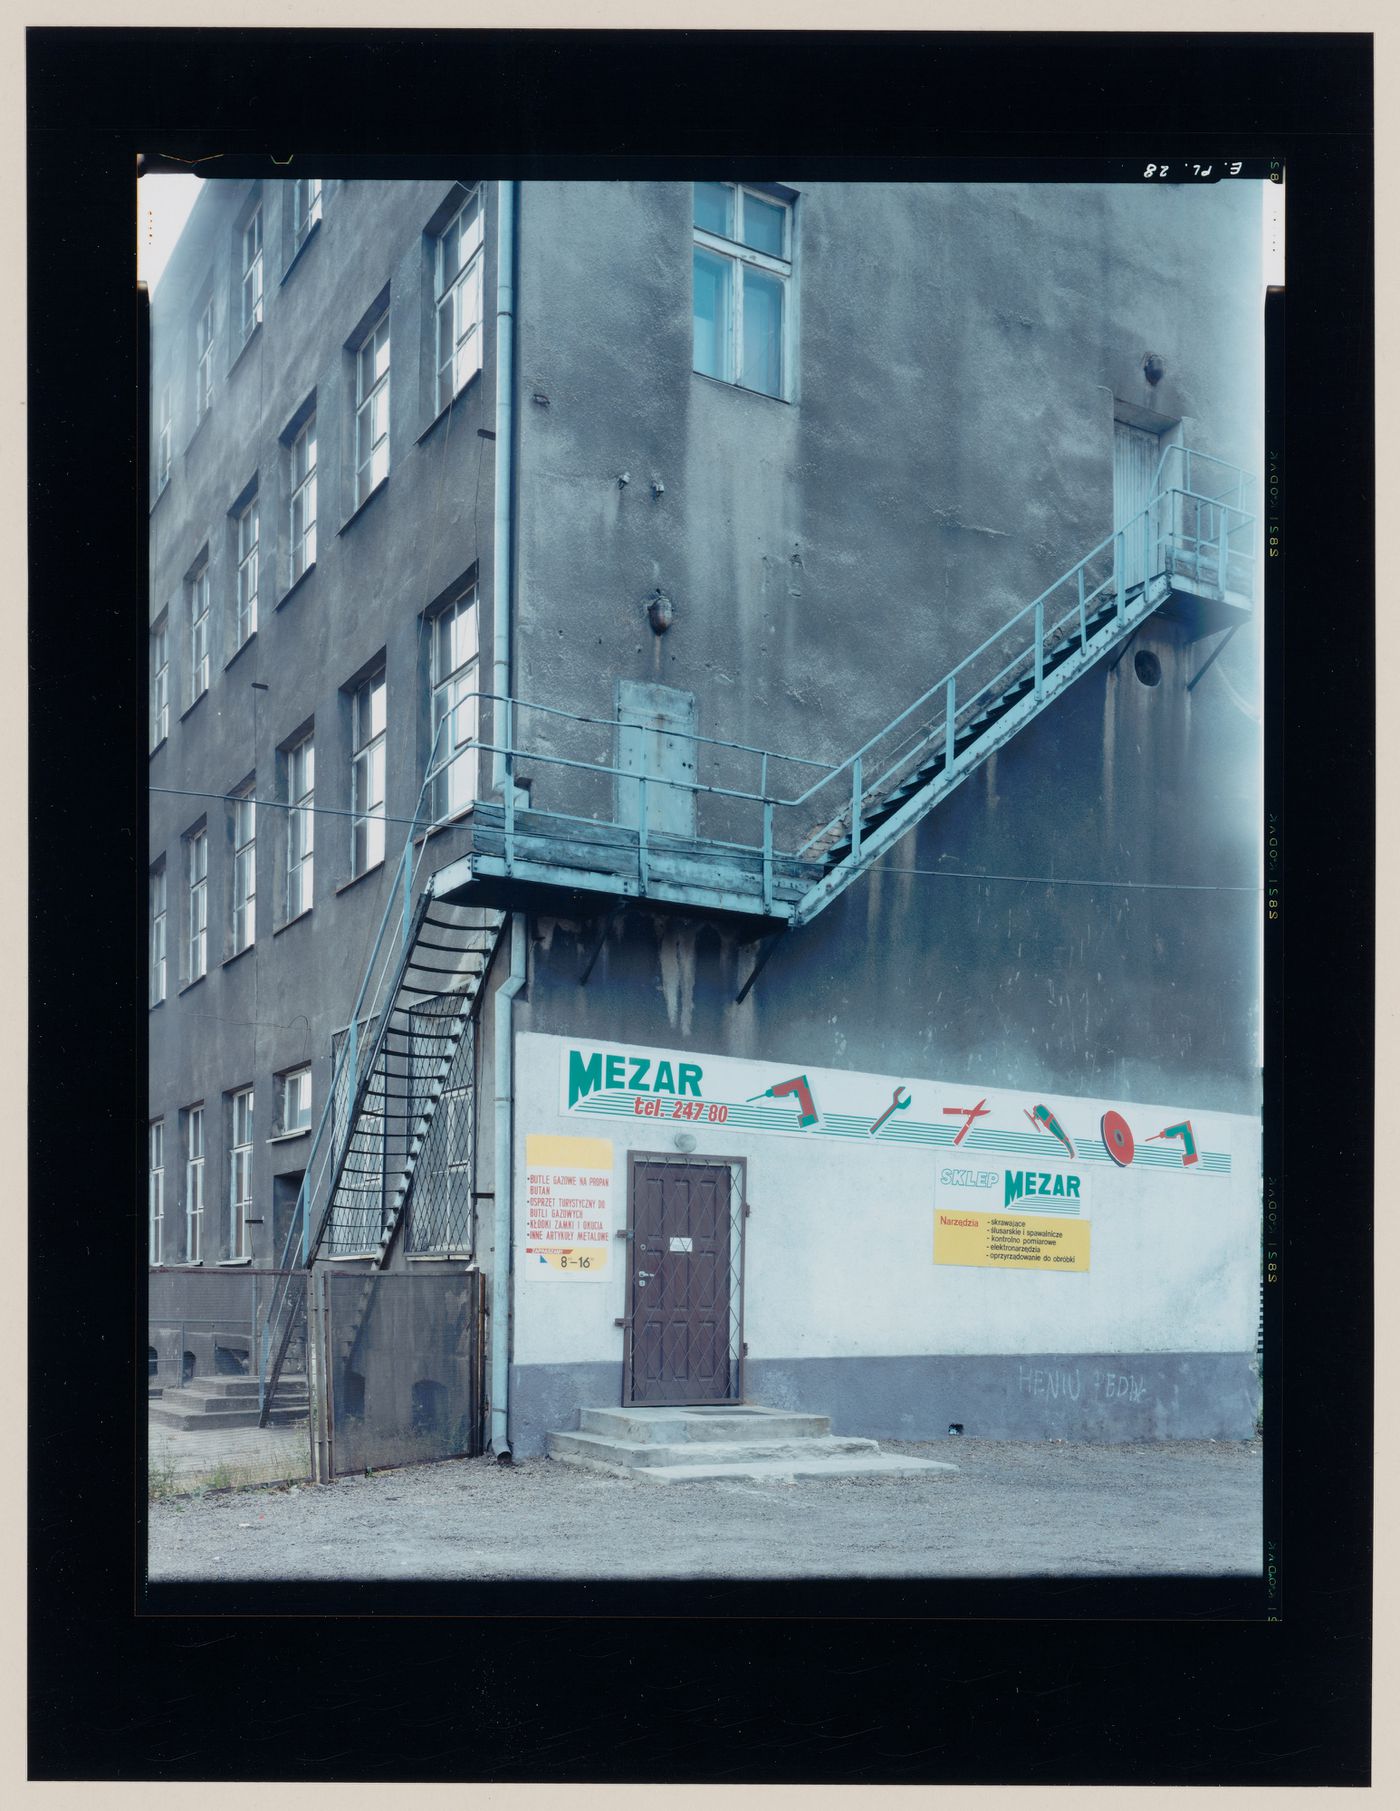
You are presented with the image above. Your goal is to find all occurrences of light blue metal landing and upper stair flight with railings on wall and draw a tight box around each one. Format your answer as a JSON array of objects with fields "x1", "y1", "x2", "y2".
[{"x1": 435, "y1": 447, "x2": 1257, "y2": 933}]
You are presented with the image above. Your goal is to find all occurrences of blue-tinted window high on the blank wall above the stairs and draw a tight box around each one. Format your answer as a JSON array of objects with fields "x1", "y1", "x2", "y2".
[{"x1": 694, "y1": 183, "x2": 791, "y2": 397}]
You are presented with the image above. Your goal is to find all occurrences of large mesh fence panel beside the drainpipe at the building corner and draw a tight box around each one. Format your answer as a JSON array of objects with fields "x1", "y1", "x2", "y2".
[{"x1": 319, "y1": 1270, "x2": 482, "y2": 1478}]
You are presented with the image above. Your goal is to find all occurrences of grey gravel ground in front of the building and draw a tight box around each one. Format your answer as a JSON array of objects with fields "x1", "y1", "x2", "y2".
[{"x1": 149, "y1": 1440, "x2": 1262, "y2": 1581}]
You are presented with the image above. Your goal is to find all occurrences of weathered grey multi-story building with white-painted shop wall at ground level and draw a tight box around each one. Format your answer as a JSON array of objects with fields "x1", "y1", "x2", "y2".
[{"x1": 149, "y1": 179, "x2": 1262, "y2": 1454}]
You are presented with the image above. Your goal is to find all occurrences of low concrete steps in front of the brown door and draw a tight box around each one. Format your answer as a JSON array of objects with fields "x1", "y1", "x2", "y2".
[{"x1": 547, "y1": 1407, "x2": 958, "y2": 1483}]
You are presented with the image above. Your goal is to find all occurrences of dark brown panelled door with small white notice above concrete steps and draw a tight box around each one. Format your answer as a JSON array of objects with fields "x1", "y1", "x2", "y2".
[{"x1": 627, "y1": 1157, "x2": 743, "y2": 1404}]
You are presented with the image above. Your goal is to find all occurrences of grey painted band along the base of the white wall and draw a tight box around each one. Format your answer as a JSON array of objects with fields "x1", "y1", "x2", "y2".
[{"x1": 511, "y1": 1353, "x2": 1259, "y2": 1458}]
